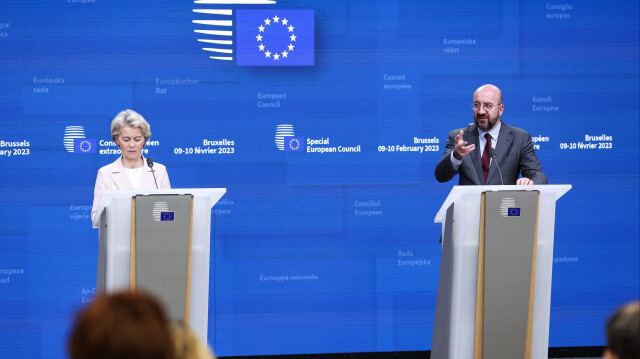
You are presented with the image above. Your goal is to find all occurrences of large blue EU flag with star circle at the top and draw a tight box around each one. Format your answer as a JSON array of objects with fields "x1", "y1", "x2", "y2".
[{"x1": 236, "y1": 10, "x2": 315, "y2": 66}]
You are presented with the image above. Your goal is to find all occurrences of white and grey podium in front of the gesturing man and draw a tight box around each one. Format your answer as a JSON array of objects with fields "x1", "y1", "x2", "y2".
[{"x1": 431, "y1": 185, "x2": 571, "y2": 359}]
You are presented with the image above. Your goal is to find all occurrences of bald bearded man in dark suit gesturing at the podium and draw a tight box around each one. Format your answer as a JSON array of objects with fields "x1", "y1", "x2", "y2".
[{"x1": 435, "y1": 84, "x2": 547, "y2": 185}]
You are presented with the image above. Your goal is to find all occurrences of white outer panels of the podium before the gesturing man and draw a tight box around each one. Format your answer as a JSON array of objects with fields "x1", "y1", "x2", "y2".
[{"x1": 431, "y1": 185, "x2": 571, "y2": 359}]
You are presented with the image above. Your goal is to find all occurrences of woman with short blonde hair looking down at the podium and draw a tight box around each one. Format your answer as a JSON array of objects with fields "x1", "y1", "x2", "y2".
[{"x1": 91, "y1": 110, "x2": 171, "y2": 221}]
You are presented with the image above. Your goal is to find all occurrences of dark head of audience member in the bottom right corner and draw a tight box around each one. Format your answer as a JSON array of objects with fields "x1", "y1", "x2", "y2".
[{"x1": 603, "y1": 301, "x2": 640, "y2": 359}]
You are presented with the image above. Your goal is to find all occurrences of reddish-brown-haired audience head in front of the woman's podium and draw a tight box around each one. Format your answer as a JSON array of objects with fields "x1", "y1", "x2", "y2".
[{"x1": 69, "y1": 292, "x2": 174, "y2": 359}]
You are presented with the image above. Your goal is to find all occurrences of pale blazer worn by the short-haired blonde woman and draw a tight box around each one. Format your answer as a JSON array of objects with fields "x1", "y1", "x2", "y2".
[{"x1": 91, "y1": 156, "x2": 171, "y2": 221}]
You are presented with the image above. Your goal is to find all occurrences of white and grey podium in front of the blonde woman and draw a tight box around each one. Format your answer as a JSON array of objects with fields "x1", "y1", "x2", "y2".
[{"x1": 93, "y1": 188, "x2": 226, "y2": 342}]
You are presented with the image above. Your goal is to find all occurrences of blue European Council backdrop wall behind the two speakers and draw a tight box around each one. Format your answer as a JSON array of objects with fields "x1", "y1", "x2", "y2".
[{"x1": 0, "y1": 0, "x2": 640, "y2": 358}]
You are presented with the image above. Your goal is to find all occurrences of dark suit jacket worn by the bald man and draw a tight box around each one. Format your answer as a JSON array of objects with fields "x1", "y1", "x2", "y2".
[{"x1": 435, "y1": 120, "x2": 547, "y2": 185}]
